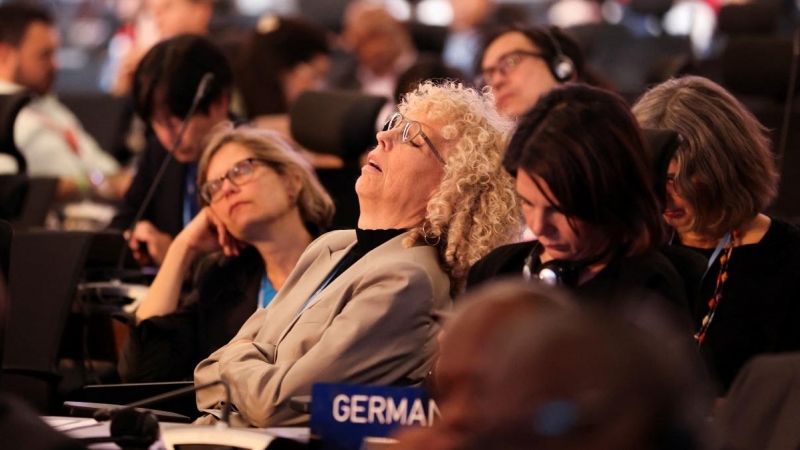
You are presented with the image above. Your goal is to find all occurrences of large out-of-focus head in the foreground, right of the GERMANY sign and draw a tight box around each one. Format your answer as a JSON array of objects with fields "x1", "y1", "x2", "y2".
[{"x1": 398, "y1": 282, "x2": 711, "y2": 450}]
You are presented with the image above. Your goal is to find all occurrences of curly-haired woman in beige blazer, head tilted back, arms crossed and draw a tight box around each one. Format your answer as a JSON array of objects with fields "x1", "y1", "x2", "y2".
[{"x1": 195, "y1": 82, "x2": 521, "y2": 427}]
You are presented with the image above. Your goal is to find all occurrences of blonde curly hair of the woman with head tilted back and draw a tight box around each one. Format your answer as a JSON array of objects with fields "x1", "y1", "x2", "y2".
[{"x1": 398, "y1": 81, "x2": 522, "y2": 292}]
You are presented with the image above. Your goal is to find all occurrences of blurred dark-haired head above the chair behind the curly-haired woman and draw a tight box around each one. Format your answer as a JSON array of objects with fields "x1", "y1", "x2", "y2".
[{"x1": 236, "y1": 15, "x2": 331, "y2": 118}]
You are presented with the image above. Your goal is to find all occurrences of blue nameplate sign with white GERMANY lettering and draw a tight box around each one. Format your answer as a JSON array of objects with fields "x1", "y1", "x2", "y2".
[{"x1": 311, "y1": 383, "x2": 440, "y2": 450}]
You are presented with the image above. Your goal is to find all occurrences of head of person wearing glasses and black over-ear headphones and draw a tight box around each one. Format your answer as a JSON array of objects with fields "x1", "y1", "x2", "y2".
[{"x1": 477, "y1": 26, "x2": 609, "y2": 118}]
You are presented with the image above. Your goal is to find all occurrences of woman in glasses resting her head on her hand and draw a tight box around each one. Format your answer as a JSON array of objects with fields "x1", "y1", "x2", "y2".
[{"x1": 119, "y1": 126, "x2": 333, "y2": 382}]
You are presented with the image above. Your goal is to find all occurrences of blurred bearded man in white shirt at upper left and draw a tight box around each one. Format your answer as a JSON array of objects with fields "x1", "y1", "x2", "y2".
[{"x1": 0, "y1": 4, "x2": 130, "y2": 199}]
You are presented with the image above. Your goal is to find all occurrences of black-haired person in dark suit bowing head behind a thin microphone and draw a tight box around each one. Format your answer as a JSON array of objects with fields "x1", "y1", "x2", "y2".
[{"x1": 111, "y1": 35, "x2": 233, "y2": 265}]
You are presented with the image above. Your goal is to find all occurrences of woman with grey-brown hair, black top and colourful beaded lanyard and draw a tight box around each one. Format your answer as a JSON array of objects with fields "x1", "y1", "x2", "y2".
[{"x1": 633, "y1": 77, "x2": 800, "y2": 395}]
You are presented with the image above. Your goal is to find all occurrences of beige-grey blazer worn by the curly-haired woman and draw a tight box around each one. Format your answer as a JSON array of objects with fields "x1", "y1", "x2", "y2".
[{"x1": 194, "y1": 230, "x2": 452, "y2": 427}]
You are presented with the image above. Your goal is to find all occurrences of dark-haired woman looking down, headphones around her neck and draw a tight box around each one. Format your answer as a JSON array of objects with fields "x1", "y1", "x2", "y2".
[{"x1": 469, "y1": 84, "x2": 687, "y2": 309}]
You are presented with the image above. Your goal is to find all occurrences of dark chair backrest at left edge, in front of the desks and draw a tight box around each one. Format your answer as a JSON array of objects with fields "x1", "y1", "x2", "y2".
[{"x1": 0, "y1": 230, "x2": 93, "y2": 413}]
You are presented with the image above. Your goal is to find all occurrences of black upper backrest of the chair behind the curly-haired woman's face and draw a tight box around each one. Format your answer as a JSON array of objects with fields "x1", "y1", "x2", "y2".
[{"x1": 289, "y1": 91, "x2": 386, "y2": 161}]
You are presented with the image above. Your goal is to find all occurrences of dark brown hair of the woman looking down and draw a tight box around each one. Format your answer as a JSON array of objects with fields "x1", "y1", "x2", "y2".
[{"x1": 503, "y1": 84, "x2": 663, "y2": 253}]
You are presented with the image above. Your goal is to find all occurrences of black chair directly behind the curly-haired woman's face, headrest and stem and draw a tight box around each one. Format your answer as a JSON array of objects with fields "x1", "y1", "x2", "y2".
[{"x1": 289, "y1": 91, "x2": 386, "y2": 229}]
